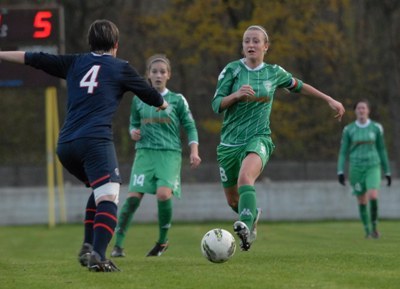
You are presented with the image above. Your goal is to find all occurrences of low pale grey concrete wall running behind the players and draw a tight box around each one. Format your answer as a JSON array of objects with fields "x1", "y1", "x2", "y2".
[{"x1": 0, "y1": 179, "x2": 400, "y2": 225}]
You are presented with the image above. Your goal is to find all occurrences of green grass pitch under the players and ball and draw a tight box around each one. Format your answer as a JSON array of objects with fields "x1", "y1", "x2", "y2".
[{"x1": 0, "y1": 221, "x2": 400, "y2": 289}]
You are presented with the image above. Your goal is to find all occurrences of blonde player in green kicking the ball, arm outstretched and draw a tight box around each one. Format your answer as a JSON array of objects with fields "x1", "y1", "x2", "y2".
[{"x1": 212, "y1": 25, "x2": 345, "y2": 251}]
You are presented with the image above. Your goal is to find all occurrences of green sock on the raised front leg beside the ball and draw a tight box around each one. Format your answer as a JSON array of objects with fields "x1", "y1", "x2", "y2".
[{"x1": 239, "y1": 185, "x2": 257, "y2": 230}]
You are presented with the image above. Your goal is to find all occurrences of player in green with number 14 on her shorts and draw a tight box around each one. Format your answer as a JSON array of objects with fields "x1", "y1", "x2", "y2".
[{"x1": 111, "y1": 54, "x2": 201, "y2": 257}]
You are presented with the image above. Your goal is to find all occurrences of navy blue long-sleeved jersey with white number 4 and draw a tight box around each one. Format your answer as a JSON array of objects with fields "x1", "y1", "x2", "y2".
[{"x1": 25, "y1": 52, "x2": 163, "y2": 143}]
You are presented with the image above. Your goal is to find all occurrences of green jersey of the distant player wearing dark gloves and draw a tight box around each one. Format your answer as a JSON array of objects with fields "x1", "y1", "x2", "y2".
[{"x1": 337, "y1": 120, "x2": 390, "y2": 175}]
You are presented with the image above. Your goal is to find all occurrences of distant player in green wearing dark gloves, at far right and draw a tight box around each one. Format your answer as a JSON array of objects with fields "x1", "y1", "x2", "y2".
[{"x1": 337, "y1": 100, "x2": 392, "y2": 239}]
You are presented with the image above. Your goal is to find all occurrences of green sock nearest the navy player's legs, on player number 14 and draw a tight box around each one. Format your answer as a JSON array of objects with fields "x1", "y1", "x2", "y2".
[{"x1": 115, "y1": 197, "x2": 141, "y2": 248}]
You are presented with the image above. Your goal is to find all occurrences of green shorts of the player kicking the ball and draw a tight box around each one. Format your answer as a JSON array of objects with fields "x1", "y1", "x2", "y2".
[{"x1": 217, "y1": 136, "x2": 275, "y2": 188}]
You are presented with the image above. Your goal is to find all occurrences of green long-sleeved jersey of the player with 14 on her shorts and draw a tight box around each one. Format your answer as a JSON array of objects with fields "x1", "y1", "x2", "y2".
[{"x1": 129, "y1": 89, "x2": 198, "y2": 151}]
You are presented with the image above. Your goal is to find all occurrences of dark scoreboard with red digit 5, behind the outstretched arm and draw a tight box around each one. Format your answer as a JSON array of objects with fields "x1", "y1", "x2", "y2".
[{"x1": 0, "y1": 6, "x2": 64, "y2": 87}]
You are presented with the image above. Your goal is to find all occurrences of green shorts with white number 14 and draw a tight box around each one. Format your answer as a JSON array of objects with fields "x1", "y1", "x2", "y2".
[{"x1": 129, "y1": 149, "x2": 182, "y2": 198}]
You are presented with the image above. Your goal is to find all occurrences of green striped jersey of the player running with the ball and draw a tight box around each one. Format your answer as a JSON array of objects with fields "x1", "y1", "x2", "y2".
[{"x1": 212, "y1": 59, "x2": 303, "y2": 146}]
